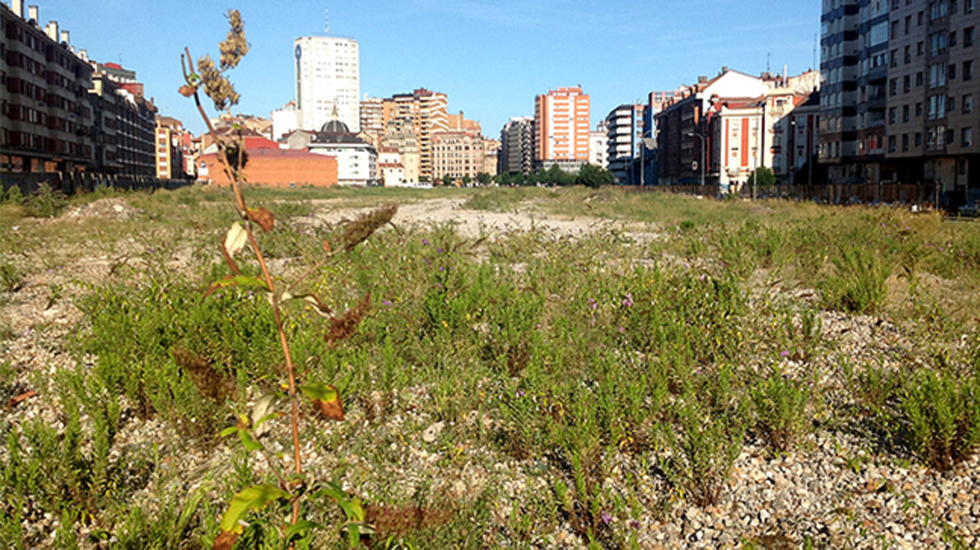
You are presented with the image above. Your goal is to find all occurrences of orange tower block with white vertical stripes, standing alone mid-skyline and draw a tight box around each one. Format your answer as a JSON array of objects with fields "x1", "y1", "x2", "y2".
[{"x1": 534, "y1": 86, "x2": 589, "y2": 168}]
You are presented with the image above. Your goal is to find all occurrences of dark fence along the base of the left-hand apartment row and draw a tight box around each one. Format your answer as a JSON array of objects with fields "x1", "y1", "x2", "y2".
[{"x1": 0, "y1": 172, "x2": 194, "y2": 199}]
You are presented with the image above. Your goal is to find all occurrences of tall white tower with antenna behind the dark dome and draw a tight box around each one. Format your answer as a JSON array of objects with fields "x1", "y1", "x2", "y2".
[{"x1": 293, "y1": 36, "x2": 361, "y2": 133}]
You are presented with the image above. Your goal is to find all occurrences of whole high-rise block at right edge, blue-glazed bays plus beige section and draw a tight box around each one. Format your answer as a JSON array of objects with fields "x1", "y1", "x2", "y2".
[{"x1": 820, "y1": 0, "x2": 980, "y2": 198}]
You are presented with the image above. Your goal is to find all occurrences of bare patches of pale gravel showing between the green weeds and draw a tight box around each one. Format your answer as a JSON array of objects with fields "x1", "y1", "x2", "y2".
[{"x1": 0, "y1": 199, "x2": 980, "y2": 549}]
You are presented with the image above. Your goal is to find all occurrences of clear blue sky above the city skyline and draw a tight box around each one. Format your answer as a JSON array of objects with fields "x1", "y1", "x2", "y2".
[{"x1": 21, "y1": 0, "x2": 820, "y2": 137}]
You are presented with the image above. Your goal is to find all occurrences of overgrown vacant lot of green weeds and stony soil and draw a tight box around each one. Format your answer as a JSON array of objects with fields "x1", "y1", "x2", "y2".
[{"x1": 0, "y1": 184, "x2": 980, "y2": 548}]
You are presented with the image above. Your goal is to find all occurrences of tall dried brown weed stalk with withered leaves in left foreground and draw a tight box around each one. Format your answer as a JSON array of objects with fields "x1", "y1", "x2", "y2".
[{"x1": 175, "y1": 10, "x2": 397, "y2": 549}]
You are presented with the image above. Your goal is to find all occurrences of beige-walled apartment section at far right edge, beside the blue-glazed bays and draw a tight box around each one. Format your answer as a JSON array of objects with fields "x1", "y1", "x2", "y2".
[{"x1": 885, "y1": 0, "x2": 980, "y2": 192}]
